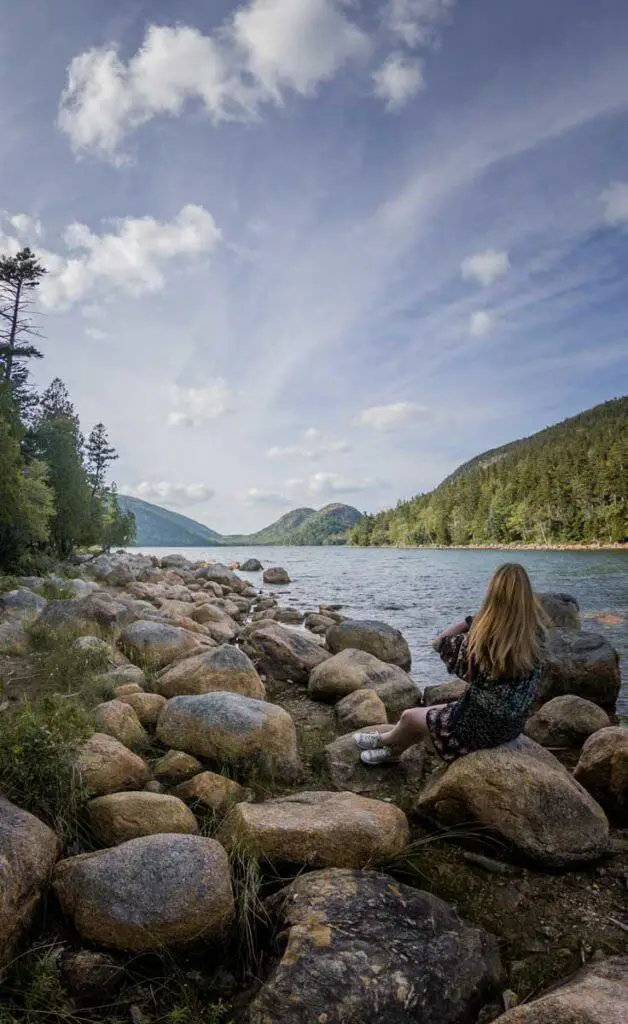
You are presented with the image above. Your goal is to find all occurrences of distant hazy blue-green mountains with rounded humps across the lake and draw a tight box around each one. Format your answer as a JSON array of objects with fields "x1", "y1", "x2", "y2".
[{"x1": 119, "y1": 495, "x2": 362, "y2": 548}]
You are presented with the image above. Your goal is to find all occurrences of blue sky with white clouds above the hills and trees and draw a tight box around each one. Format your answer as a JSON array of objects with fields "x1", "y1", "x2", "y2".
[{"x1": 0, "y1": 0, "x2": 628, "y2": 531}]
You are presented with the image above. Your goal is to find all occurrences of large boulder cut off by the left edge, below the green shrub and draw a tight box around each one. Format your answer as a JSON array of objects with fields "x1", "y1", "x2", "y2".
[{"x1": 0, "y1": 797, "x2": 60, "y2": 974}]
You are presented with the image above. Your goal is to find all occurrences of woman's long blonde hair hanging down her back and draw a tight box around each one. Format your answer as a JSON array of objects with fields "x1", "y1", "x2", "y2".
[{"x1": 467, "y1": 562, "x2": 548, "y2": 679}]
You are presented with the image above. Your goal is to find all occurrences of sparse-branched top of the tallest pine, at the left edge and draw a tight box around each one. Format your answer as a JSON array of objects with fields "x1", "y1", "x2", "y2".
[{"x1": 0, "y1": 249, "x2": 47, "y2": 383}]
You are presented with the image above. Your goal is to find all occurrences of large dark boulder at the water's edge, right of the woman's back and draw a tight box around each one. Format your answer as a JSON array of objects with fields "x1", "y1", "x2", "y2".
[{"x1": 540, "y1": 629, "x2": 621, "y2": 712}]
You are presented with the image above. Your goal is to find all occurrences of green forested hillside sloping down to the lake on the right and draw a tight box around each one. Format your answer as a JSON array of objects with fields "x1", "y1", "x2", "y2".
[{"x1": 349, "y1": 397, "x2": 628, "y2": 547}]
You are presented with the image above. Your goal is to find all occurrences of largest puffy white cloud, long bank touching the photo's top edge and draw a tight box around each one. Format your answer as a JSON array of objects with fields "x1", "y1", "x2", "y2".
[{"x1": 57, "y1": 0, "x2": 370, "y2": 163}]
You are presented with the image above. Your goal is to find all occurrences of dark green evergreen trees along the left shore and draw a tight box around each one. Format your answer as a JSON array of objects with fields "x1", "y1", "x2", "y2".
[{"x1": 0, "y1": 249, "x2": 135, "y2": 572}]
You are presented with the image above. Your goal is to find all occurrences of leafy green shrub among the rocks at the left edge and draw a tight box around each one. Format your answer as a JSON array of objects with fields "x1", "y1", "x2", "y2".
[{"x1": 0, "y1": 693, "x2": 93, "y2": 841}]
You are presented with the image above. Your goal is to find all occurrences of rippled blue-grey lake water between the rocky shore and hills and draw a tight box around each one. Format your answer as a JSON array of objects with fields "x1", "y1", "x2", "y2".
[{"x1": 133, "y1": 547, "x2": 628, "y2": 718}]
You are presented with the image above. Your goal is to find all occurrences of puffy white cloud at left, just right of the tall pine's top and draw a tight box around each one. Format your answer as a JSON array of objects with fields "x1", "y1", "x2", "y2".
[{"x1": 0, "y1": 205, "x2": 220, "y2": 307}]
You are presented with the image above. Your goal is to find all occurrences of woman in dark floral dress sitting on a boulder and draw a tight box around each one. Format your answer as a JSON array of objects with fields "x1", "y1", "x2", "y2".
[{"x1": 354, "y1": 563, "x2": 548, "y2": 765}]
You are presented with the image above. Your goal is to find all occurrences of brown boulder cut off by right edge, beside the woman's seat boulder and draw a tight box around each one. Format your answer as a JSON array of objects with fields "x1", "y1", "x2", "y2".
[{"x1": 574, "y1": 725, "x2": 628, "y2": 826}]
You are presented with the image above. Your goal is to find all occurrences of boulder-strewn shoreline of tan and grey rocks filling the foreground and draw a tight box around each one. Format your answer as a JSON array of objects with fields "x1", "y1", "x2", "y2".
[{"x1": 0, "y1": 553, "x2": 628, "y2": 1024}]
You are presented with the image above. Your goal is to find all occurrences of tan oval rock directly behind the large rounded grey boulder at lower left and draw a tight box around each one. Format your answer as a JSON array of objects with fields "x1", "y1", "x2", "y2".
[{"x1": 87, "y1": 792, "x2": 199, "y2": 846}]
